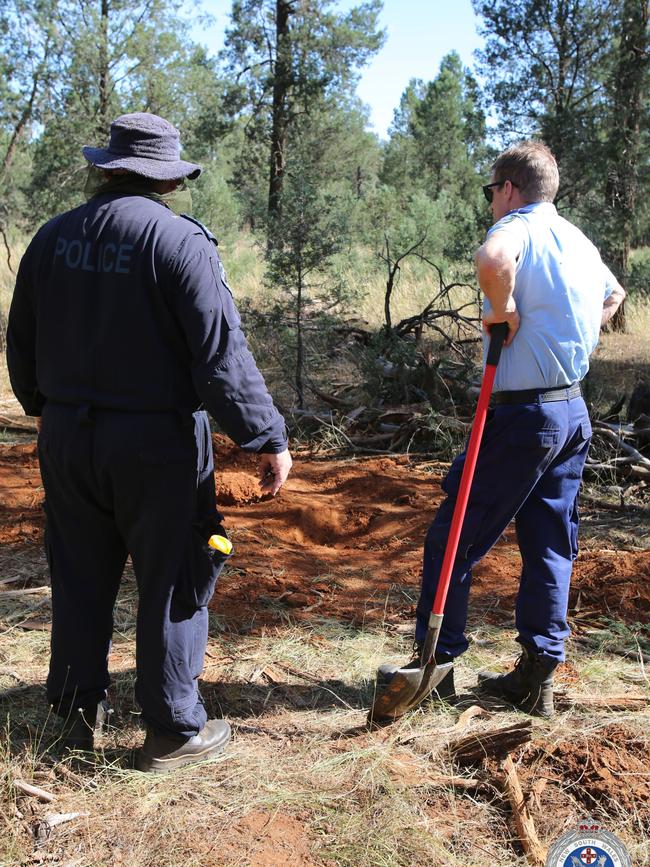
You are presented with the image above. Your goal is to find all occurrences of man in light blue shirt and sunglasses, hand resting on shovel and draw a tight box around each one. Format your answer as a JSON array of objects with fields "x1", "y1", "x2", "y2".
[{"x1": 380, "y1": 142, "x2": 625, "y2": 717}]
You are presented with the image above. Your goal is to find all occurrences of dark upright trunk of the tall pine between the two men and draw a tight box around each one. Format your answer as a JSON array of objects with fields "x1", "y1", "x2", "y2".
[{"x1": 268, "y1": 0, "x2": 293, "y2": 217}]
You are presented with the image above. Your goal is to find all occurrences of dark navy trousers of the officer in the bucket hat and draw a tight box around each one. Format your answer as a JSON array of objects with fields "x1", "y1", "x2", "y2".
[{"x1": 38, "y1": 403, "x2": 225, "y2": 737}]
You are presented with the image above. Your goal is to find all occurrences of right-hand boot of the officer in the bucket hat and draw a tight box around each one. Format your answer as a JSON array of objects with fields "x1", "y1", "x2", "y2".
[{"x1": 135, "y1": 719, "x2": 230, "y2": 774}]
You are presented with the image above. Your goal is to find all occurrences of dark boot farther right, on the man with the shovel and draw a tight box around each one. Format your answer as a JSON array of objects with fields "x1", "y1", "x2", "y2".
[{"x1": 478, "y1": 644, "x2": 558, "y2": 719}]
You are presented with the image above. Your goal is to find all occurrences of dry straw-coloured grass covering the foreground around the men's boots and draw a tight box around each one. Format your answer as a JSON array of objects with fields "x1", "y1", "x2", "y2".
[{"x1": 0, "y1": 550, "x2": 650, "y2": 867}]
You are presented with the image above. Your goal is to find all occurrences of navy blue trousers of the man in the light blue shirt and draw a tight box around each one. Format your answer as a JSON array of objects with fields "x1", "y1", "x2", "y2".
[{"x1": 416, "y1": 397, "x2": 591, "y2": 661}]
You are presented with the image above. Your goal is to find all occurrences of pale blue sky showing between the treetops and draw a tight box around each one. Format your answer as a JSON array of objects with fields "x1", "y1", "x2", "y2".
[{"x1": 192, "y1": 0, "x2": 482, "y2": 138}]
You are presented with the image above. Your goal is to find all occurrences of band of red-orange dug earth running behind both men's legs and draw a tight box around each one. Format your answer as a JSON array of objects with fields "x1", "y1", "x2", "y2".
[{"x1": 0, "y1": 436, "x2": 650, "y2": 630}]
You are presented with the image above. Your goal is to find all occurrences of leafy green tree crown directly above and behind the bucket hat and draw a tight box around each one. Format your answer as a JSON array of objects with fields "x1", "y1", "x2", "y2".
[{"x1": 14, "y1": 0, "x2": 222, "y2": 225}]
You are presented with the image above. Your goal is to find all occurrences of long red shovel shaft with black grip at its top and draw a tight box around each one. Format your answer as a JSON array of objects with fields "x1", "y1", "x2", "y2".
[{"x1": 433, "y1": 322, "x2": 508, "y2": 616}]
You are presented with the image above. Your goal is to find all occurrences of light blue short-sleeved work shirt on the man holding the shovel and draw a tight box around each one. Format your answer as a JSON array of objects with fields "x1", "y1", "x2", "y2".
[{"x1": 484, "y1": 202, "x2": 617, "y2": 391}]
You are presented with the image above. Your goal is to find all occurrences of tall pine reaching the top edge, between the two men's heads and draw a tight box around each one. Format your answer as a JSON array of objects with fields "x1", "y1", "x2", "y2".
[{"x1": 223, "y1": 0, "x2": 383, "y2": 218}]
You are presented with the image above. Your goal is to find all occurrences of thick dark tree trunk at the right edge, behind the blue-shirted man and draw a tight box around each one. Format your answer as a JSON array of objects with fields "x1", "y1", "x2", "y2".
[{"x1": 606, "y1": 0, "x2": 649, "y2": 331}]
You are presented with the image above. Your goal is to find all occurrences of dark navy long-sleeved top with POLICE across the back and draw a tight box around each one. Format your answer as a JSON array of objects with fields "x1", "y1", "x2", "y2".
[{"x1": 7, "y1": 194, "x2": 287, "y2": 452}]
